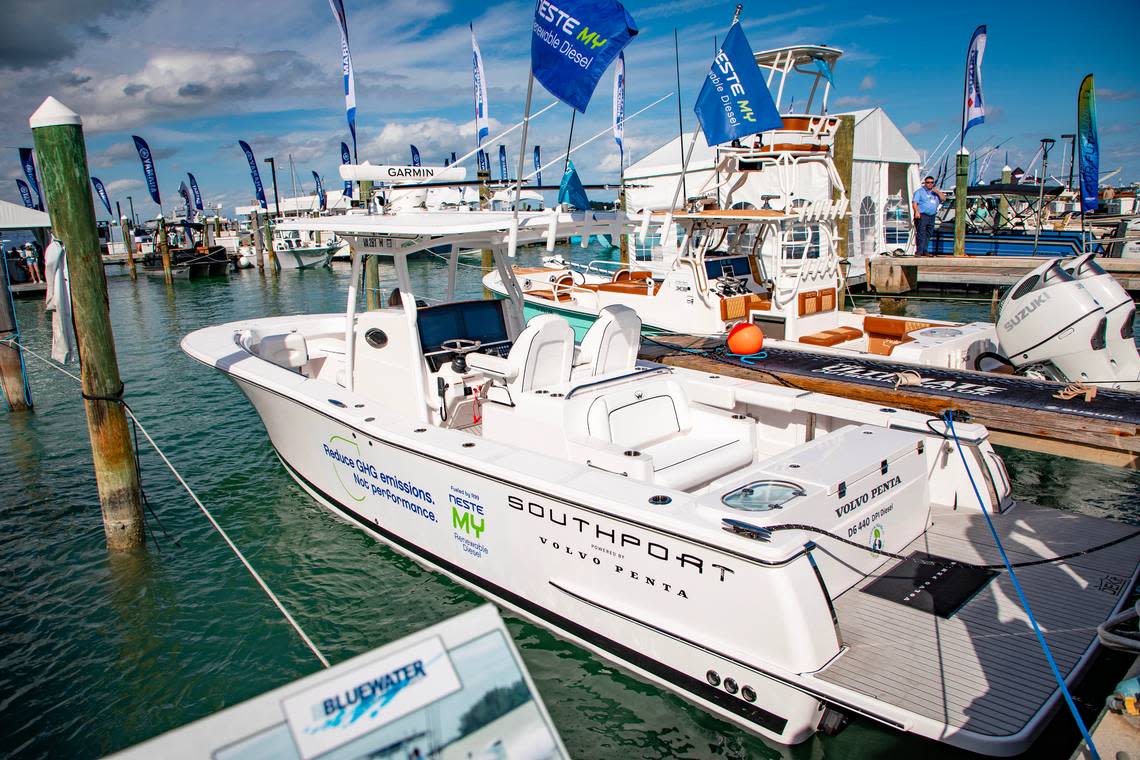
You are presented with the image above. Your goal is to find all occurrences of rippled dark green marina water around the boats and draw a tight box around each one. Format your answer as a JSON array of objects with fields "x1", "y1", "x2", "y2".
[{"x1": 0, "y1": 248, "x2": 1140, "y2": 759}]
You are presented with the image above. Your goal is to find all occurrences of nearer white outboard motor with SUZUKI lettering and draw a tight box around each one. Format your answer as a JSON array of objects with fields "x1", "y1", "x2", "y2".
[{"x1": 995, "y1": 259, "x2": 1115, "y2": 385}]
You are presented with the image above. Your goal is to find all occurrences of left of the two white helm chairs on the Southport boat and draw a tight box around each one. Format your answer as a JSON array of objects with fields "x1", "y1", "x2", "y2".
[{"x1": 467, "y1": 314, "x2": 573, "y2": 403}]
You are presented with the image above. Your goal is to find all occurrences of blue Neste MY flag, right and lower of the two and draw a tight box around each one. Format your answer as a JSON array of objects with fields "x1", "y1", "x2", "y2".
[{"x1": 694, "y1": 24, "x2": 783, "y2": 147}]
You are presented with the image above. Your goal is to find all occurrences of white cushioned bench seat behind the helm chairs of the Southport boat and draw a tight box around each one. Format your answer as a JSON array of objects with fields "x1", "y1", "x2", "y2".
[{"x1": 574, "y1": 381, "x2": 756, "y2": 490}]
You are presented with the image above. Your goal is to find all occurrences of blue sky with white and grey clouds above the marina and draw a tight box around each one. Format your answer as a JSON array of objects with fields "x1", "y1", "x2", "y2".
[{"x1": 0, "y1": 0, "x2": 1140, "y2": 219}]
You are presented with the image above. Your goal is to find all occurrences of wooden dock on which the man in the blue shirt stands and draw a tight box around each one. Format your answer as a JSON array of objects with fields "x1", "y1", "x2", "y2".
[{"x1": 866, "y1": 256, "x2": 1140, "y2": 297}]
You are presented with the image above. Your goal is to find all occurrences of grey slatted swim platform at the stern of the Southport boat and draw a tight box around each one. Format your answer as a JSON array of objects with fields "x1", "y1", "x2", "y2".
[{"x1": 815, "y1": 504, "x2": 1140, "y2": 744}]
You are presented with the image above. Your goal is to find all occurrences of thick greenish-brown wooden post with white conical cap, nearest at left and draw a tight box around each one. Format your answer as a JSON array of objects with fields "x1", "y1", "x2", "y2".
[{"x1": 30, "y1": 98, "x2": 144, "y2": 551}]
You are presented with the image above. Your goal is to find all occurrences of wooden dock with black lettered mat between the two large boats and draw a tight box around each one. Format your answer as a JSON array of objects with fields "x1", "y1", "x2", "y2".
[{"x1": 641, "y1": 335, "x2": 1140, "y2": 469}]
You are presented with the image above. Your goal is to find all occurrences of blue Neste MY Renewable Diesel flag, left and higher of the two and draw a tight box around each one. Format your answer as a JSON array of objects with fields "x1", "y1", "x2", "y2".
[{"x1": 530, "y1": 0, "x2": 637, "y2": 113}]
